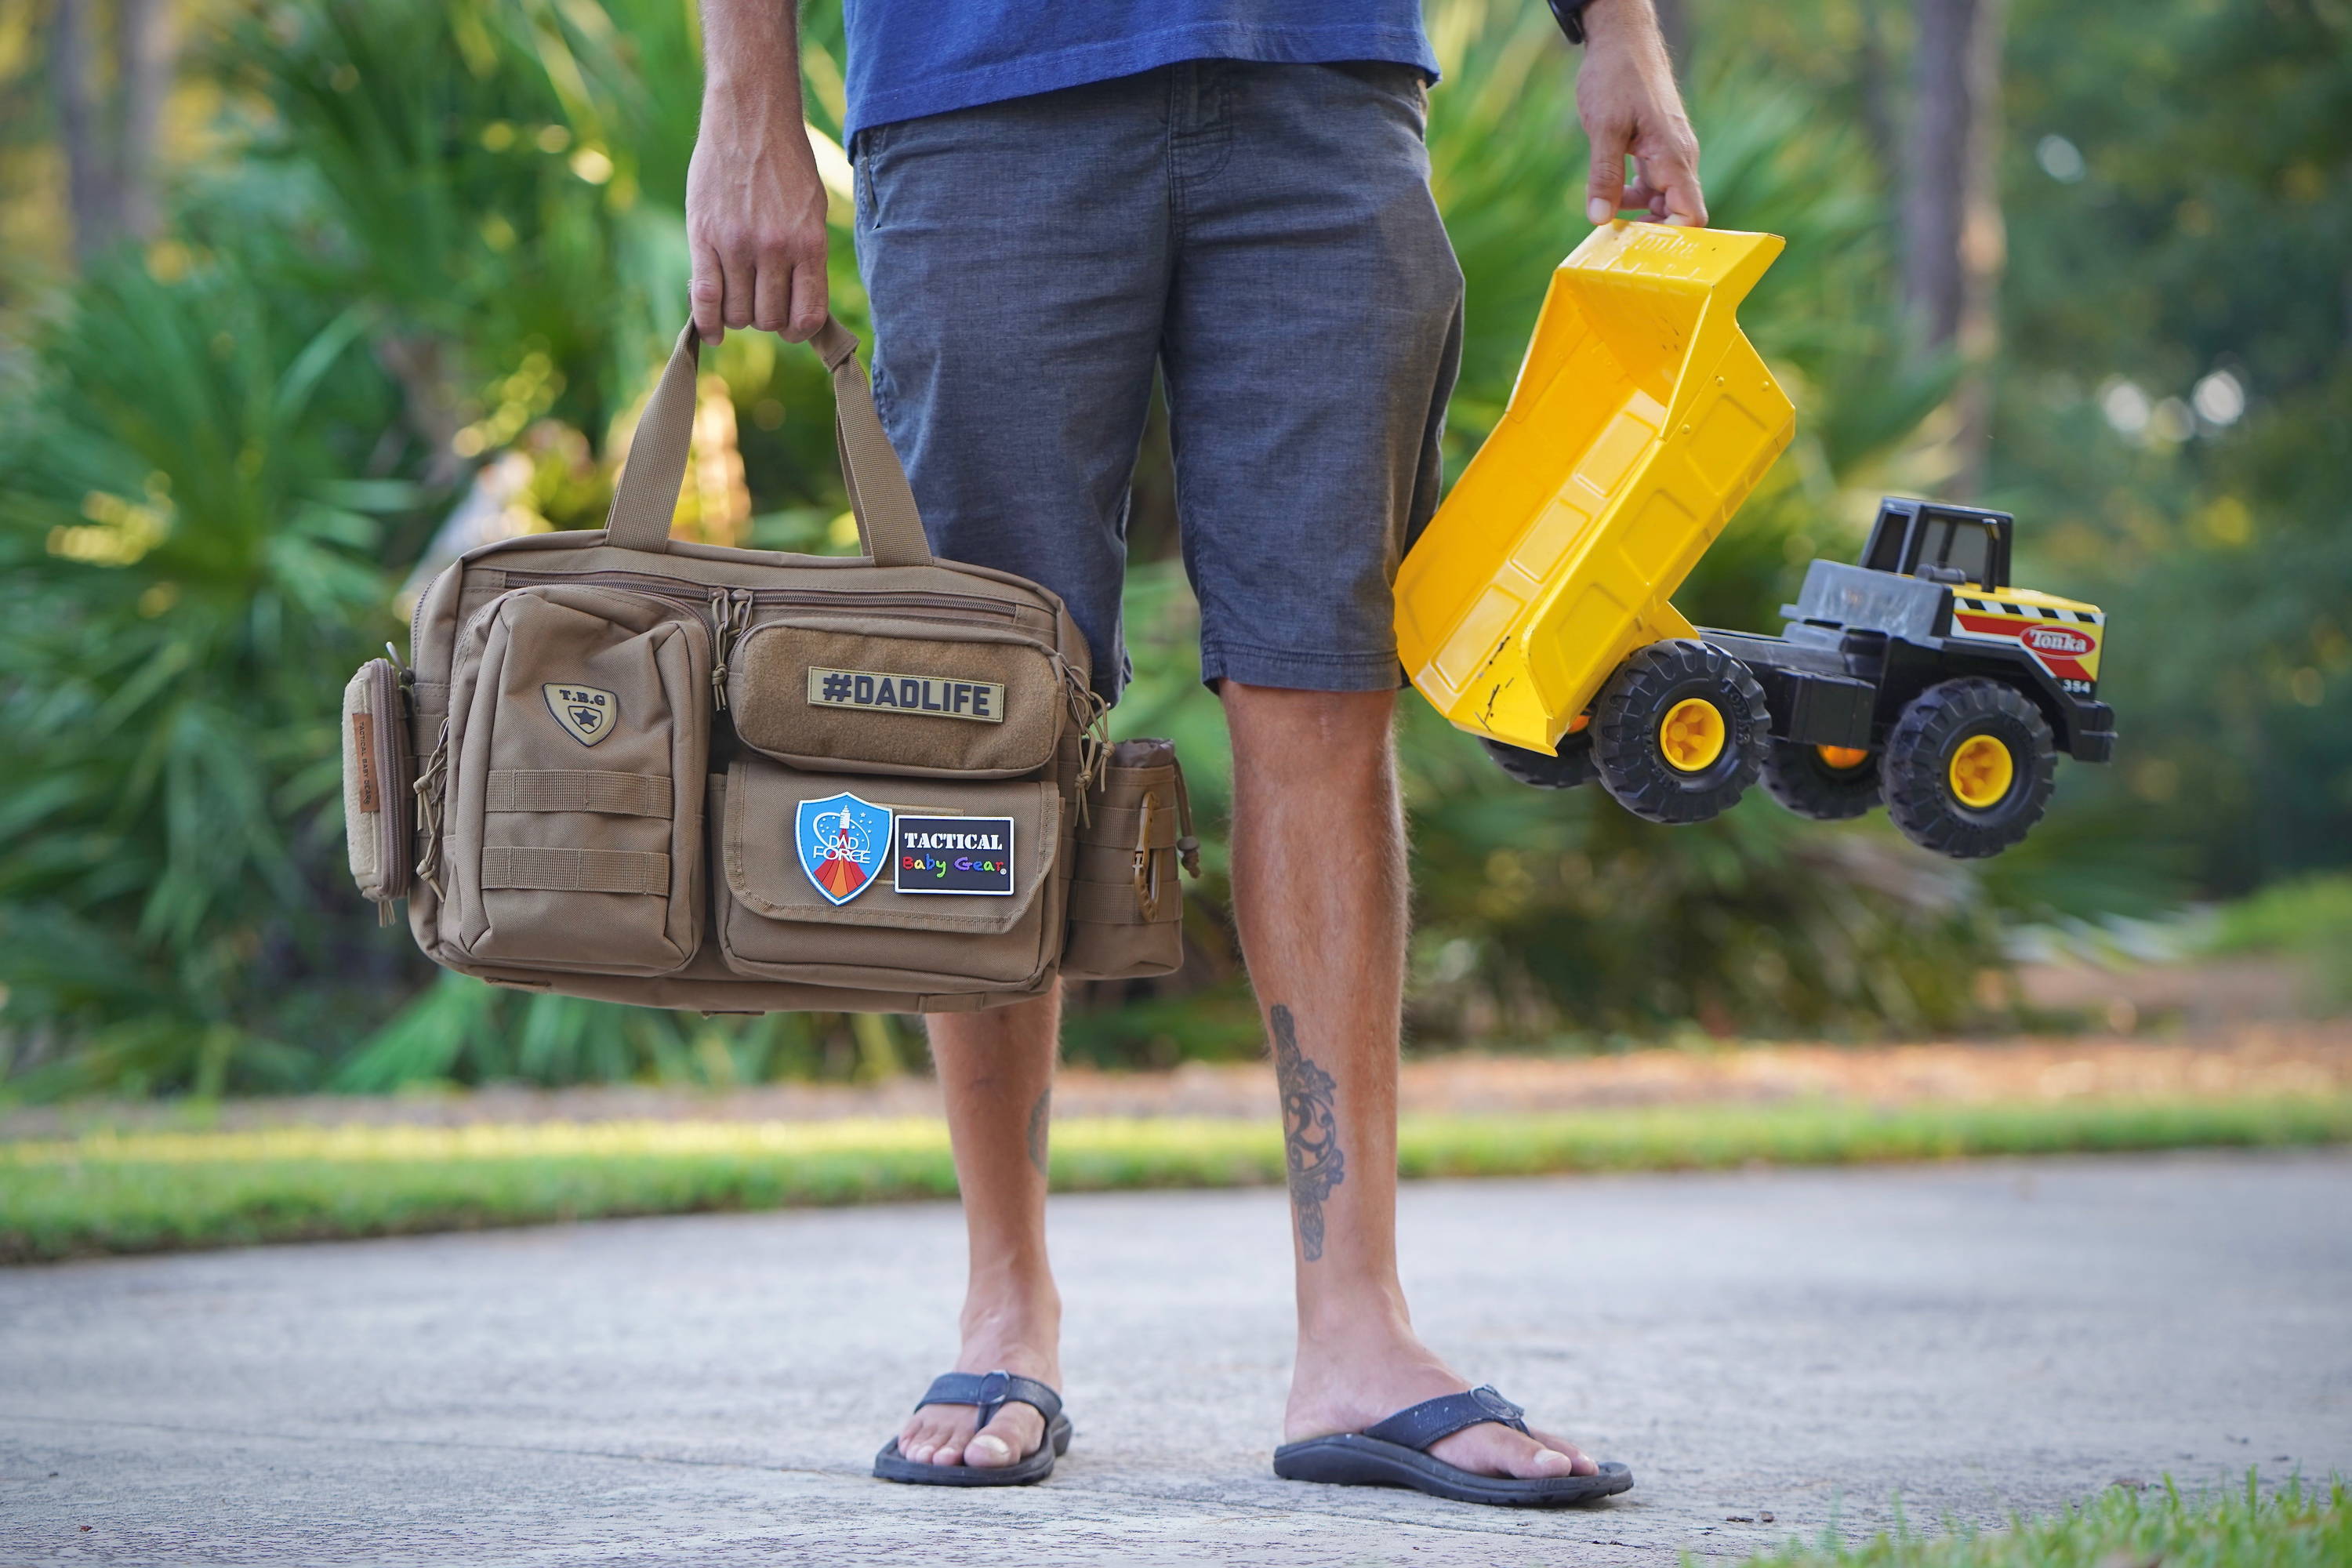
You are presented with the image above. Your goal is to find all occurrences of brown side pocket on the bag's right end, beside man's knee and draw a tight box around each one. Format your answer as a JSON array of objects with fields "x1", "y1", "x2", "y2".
[{"x1": 1061, "y1": 741, "x2": 1200, "y2": 980}]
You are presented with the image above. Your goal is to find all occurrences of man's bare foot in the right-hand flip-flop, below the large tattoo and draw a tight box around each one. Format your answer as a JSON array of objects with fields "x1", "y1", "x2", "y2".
[{"x1": 1282, "y1": 1321, "x2": 1599, "y2": 1481}]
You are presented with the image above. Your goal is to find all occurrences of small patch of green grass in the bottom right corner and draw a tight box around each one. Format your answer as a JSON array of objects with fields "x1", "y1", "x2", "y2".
[{"x1": 1722, "y1": 1474, "x2": 2352, "y2": 1568}]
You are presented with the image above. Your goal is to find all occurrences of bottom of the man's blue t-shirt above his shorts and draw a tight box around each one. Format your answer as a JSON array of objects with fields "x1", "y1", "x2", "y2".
[{"x1": 842, "y1": 0, "x2": 1437, "y2": 136}]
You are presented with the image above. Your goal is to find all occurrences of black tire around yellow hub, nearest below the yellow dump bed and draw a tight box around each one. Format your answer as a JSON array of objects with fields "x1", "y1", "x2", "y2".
[{"x1": 1590, "y1": 637, "x2": 1771, "y2": 822}]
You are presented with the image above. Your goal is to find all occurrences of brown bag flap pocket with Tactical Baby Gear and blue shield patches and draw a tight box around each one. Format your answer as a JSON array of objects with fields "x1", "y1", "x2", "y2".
[{"x1": 710, "y1": 757, "x2": 1063, "y2": 994}]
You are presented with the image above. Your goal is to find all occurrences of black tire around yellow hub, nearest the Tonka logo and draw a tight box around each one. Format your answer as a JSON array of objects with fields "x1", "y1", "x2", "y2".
[{"x1": 1879, "y1": 680, "x2": 2058, "y2": 860}]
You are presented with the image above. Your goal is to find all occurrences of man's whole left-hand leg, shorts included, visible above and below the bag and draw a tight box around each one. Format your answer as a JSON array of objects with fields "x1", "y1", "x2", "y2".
[{"x1": 858, "y1": 78, "x2": 1169, "y2": 1467}]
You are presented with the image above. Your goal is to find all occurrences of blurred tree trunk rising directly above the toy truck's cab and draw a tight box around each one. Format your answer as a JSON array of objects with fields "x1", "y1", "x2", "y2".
[{"x1": 1903, "y1": 0, "x2": 2004, "y2": 494}]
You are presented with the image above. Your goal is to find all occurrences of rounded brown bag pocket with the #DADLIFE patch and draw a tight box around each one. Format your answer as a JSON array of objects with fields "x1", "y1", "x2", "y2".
[{"x1": 727, "y1": 616, "x2": 1073, "y2": 779}]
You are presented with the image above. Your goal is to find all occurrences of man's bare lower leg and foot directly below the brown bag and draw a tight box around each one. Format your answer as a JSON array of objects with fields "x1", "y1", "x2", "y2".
[{"x1": 898, "y1": 992, "x2": 1061, "y2": 1467}]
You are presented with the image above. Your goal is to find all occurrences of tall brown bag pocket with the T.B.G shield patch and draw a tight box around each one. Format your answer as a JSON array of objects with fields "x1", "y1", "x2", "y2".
[{"x1": 442, "y1": 586, "x2": 710, "y2": 973}]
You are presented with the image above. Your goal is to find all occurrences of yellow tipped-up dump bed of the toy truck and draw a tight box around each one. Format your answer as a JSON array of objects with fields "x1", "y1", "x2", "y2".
[{"x1": 1397, "y1": 223, "x2": 1797, "y2": 753}]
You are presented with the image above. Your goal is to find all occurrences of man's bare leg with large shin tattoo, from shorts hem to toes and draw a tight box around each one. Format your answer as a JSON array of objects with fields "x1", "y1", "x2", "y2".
[{"x1": 1223, "y1": 680, "x2": 1597, "y2": 1476}]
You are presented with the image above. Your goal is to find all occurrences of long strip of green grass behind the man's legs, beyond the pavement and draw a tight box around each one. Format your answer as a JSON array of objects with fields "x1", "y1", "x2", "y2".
[{"x1": 0, "y1": 1095, "x2": 2352, "y2": 1262}]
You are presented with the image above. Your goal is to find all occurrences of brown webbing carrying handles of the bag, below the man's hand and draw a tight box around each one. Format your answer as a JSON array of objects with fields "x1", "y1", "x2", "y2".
[{"x1": 604, "y1": 315, "x2": 931, "y2": 567}]
